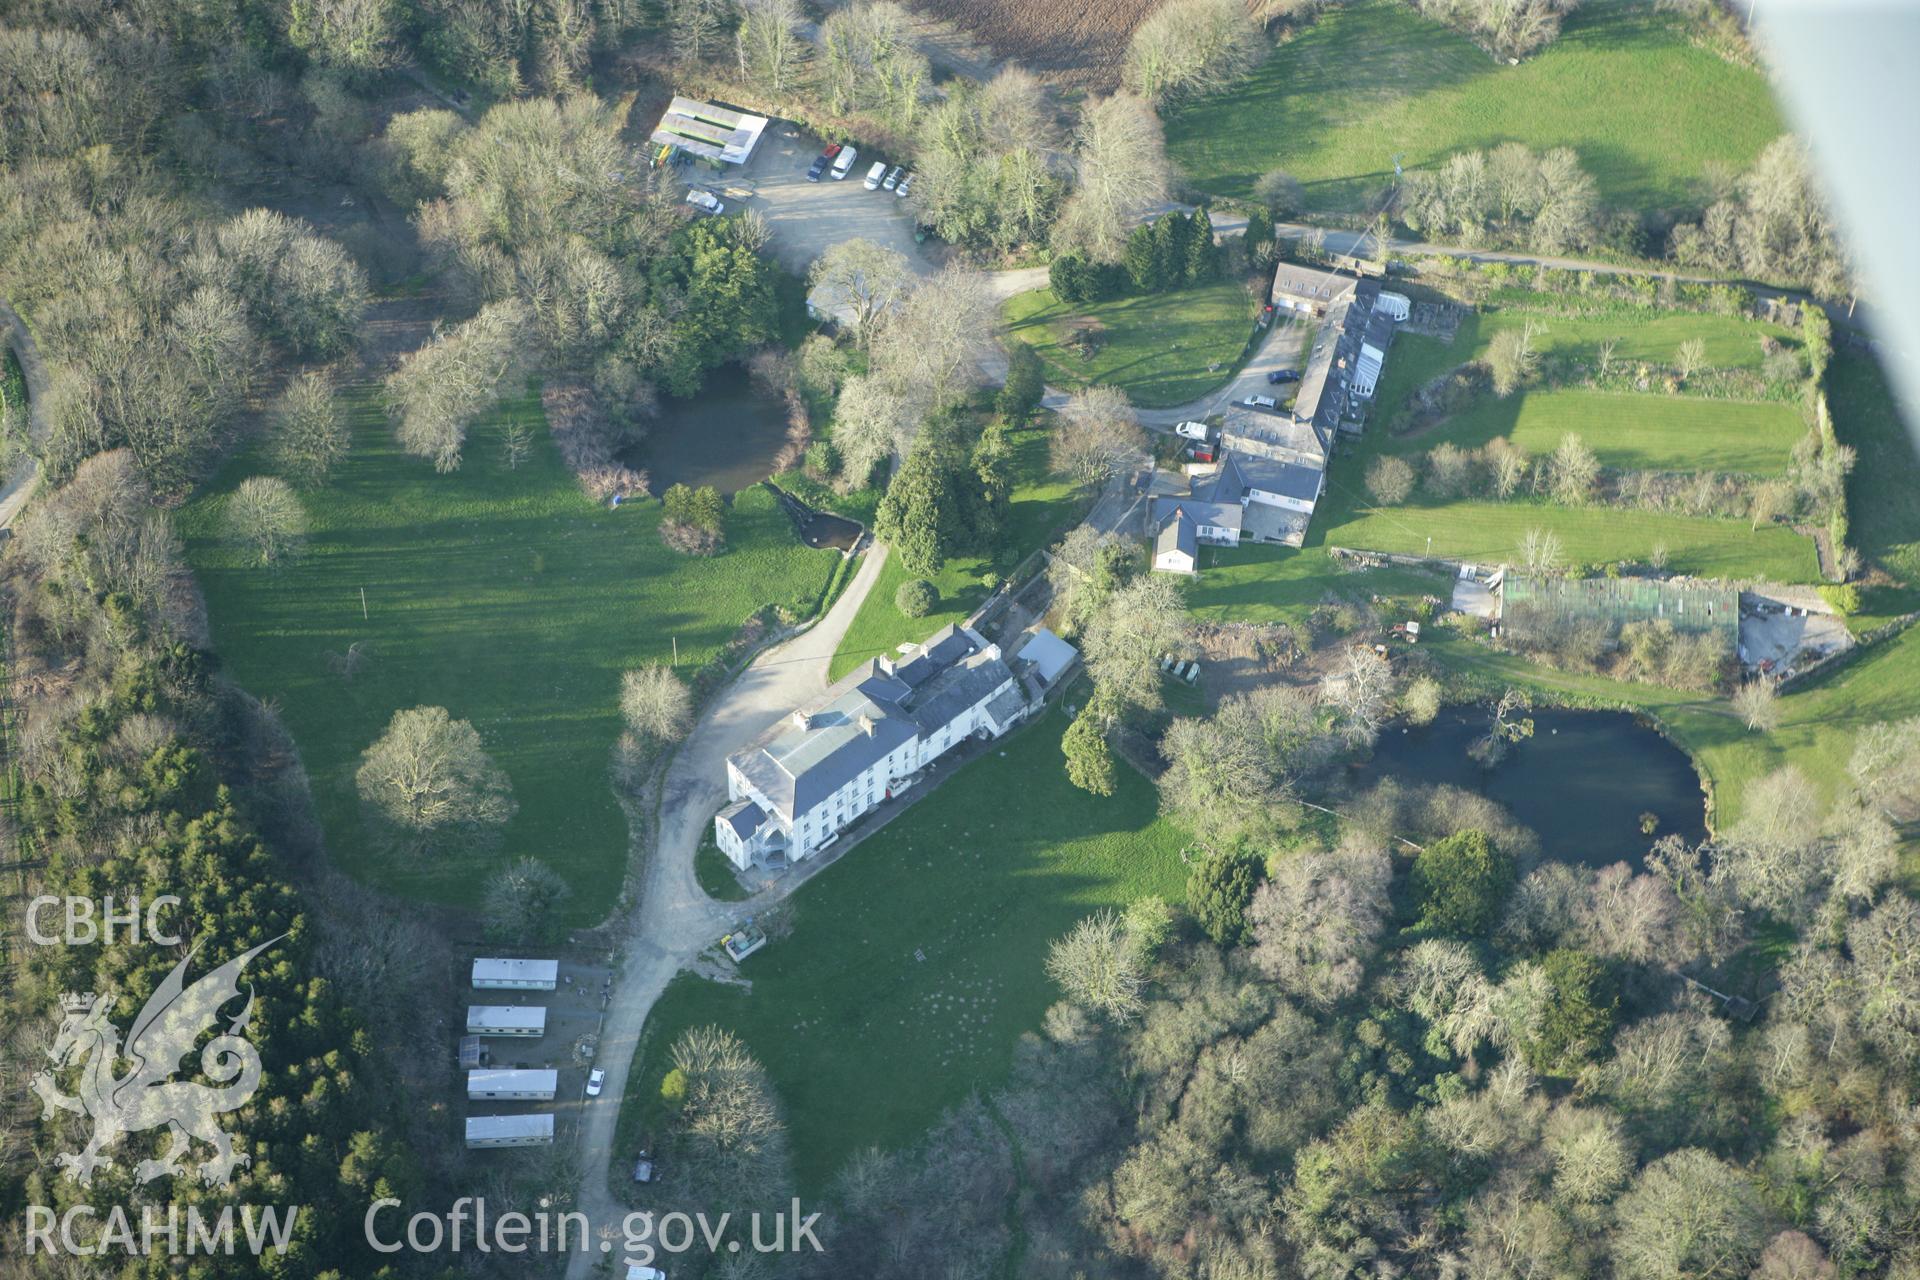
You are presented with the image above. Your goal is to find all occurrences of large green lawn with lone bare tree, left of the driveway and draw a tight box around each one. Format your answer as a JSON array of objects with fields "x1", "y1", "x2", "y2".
[{"x1": 180, "y1": 385, "x2": 835, "y2": 925}]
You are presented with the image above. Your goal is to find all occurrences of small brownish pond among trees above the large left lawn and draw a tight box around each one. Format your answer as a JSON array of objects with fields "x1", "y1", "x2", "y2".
[{"x1": 626, "y1": 365, "x2": 787, "y2": 493}]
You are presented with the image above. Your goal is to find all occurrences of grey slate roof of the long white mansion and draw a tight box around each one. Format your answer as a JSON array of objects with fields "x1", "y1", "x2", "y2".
[{"x1": 730, "y1": 626, "x2": 1014, "y2": 831}]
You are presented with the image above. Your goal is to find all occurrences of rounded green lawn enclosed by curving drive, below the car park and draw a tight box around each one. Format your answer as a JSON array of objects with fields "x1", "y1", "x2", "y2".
[{"x1": 1002, "y1": 280, "x2": 1258, "y2": 409}]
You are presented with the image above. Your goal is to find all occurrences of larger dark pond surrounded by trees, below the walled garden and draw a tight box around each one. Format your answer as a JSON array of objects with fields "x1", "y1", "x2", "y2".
[{"x1": 1356, "y1": 706, "x2": 1707, "y2": 867}]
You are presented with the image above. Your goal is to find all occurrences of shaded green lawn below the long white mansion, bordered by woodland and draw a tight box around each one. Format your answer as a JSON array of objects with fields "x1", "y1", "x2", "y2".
[{"x1": 620, "y1": 710, "x2": 1187, "y2": 1196}]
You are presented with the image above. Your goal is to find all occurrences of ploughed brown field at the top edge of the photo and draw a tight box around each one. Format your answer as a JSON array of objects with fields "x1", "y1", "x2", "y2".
[{"x1": 908, "y1": 0, "x2": 1160, "y2": 83}]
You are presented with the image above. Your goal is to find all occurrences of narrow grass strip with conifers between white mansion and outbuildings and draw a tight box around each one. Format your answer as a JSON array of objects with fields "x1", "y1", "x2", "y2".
[{"x1": 829, "y1": 418, "x2": 1087, "y2": 679}]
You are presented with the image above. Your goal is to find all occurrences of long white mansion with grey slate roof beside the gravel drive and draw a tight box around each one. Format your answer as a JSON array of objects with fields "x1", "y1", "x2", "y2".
[{"x1": 714, "y1": 626, "x2": 1029, "y2": 869}]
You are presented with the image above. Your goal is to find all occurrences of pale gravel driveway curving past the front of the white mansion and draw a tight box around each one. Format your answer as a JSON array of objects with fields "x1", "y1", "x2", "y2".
[{"x1": 566, "y1": 545, "x2": 887, "y2": 1280}]
